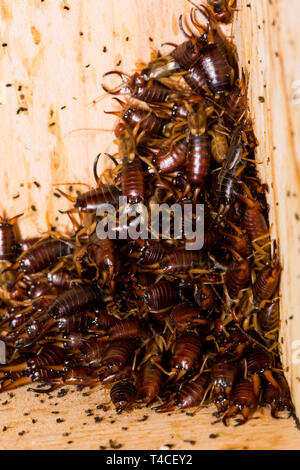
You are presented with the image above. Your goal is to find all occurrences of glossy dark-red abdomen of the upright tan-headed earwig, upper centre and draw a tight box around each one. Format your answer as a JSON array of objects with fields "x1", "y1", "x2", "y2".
[{"x1": 186, "y1": 134, "x2": 211, "y2": 189}]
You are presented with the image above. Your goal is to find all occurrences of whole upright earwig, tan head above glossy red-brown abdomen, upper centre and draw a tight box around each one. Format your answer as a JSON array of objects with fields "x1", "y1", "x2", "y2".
[{"x1": 186, "y1": 107, "x2": 211, "y2": 190}]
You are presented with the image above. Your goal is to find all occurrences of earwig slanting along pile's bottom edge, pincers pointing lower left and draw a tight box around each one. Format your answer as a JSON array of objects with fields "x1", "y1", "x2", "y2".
[{"x1": 153, "y1": 375, "x2": 208, "y2": 413}]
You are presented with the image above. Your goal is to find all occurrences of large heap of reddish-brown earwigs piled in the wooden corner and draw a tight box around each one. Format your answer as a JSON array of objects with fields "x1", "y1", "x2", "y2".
[{"x1": 0, "y1": 0, "x2": 293, "y2": 425}]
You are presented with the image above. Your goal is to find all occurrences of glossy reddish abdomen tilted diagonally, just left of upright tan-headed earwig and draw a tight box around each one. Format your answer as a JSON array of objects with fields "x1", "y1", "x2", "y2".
[{"x1": 155, "y1": 141, "x2": 187, "y2": 174}]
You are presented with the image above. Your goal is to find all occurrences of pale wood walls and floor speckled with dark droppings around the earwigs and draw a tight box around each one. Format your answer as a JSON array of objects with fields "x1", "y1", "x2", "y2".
[{"x1": 0, "y1": 0, "x2": 300, "y2": 449}]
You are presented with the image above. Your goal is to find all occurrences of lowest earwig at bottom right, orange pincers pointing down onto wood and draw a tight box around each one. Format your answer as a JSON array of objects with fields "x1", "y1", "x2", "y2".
[{"x1": 223, "y1": 380, "x2": 258, "y2": 426}]
